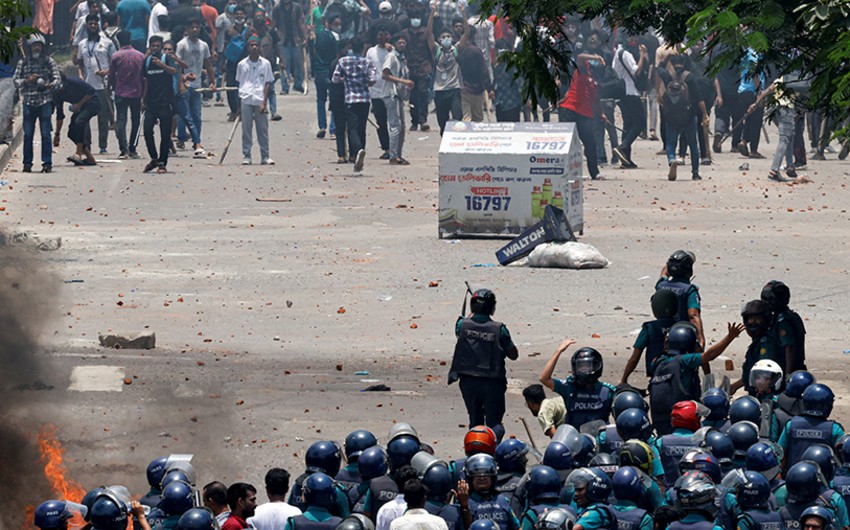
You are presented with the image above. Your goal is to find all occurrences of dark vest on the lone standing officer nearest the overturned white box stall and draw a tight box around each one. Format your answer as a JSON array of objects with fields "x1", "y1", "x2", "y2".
[{"x1": 451, "y1": 318, "x2": 507, "y2": 379}]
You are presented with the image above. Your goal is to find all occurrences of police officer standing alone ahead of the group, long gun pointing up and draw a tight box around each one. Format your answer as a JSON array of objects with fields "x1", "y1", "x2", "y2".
[{"x1": 449, "y1": 289, "x2": 519, "y2": 440}]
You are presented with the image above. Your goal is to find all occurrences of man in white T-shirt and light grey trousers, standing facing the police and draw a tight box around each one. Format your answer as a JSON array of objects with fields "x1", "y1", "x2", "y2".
[{"x1": 236, "y1": 36, "x2": 274, "y2": 165}]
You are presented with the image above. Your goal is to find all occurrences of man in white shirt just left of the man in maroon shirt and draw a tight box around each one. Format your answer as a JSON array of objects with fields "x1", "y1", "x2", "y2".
[{"x1": 74, "y1": 13, "x2": 115, "y2": 154}]
